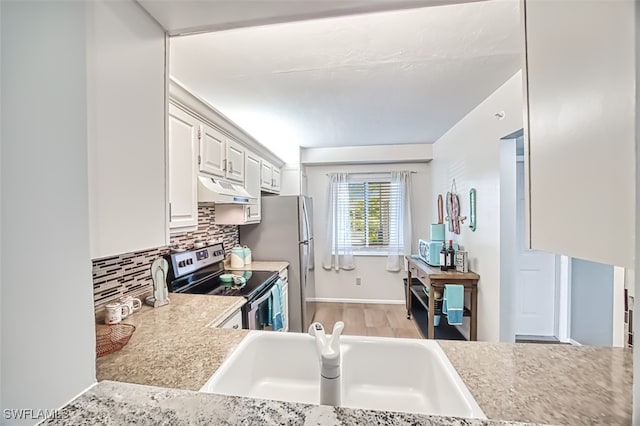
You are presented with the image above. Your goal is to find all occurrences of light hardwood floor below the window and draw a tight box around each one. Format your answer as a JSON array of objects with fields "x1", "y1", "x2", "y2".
[{"x1": 313, "y1": 302, "x2": 422, "y2": 339}]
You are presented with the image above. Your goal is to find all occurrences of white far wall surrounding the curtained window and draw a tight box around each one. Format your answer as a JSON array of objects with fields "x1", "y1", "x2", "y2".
[{"x1": 306, "y1": 163, "x2": 433, "y2": 302}]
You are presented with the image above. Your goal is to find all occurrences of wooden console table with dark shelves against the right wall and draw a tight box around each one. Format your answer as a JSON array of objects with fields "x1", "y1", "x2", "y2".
[{"x1": 405, "y1": 256, "x2": 480, "y2": 340}]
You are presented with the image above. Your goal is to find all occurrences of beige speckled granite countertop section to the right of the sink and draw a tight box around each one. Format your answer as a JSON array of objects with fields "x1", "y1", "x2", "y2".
[{"x1": 438, "y1": 340, "x2": 633, "y2": 425}]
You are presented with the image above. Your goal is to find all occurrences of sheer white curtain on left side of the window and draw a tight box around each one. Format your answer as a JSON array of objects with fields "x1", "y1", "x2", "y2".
[{"x1": 322, "y1": 173, "x2": 355, "y2": 271}]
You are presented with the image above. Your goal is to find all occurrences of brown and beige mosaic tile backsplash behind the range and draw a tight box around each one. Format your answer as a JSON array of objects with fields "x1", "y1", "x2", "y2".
[{"x1": 93, "y1": 206, "x2": 239, "y2": 311}]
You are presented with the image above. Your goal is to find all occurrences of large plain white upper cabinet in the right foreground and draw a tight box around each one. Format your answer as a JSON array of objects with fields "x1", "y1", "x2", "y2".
[{"x1": 524, "y1": 0, "x2": 636, "y2": 267}]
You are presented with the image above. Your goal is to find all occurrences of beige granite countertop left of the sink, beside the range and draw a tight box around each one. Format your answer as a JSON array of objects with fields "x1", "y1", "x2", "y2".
[{"x1": 96, "y1": 293, "x2": 248, "y2": 390}]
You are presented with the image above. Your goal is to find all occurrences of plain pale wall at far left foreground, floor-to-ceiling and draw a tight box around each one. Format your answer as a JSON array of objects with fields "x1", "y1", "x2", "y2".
[{"x1": 0, "y1": 2, "x2": 96, "y2": 424}]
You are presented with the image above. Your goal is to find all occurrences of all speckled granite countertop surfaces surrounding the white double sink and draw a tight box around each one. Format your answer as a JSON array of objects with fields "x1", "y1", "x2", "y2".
[{"x1": 92, "y1": 292, "x2": 632, "y2": 426}]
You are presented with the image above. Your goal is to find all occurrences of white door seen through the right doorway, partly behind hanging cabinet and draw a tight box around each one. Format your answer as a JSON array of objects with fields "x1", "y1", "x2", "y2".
[{"x1": 515, "y1": 162, "x2": 557, "y2": 336}]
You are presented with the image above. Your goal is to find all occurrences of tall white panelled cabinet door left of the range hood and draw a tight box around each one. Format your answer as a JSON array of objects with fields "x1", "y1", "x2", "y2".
[{"x1": 169, "y1": 105, "x2": 199, "y2": 228}]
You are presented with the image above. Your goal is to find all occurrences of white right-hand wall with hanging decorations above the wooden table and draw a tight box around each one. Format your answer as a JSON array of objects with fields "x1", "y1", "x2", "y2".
[{"x1": 430, "y1": 72, "x2": 522, "y2": 342}]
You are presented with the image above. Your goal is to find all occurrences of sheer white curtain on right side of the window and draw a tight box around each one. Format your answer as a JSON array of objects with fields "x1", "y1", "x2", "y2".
[{"x1": 387, "y1": 172, "x2": 412, "y2": 272}]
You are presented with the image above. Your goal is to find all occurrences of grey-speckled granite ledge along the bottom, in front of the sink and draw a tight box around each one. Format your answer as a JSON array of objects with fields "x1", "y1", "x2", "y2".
[{"x1": 41, "y1": 381, "x2": 536, "y2": 426}]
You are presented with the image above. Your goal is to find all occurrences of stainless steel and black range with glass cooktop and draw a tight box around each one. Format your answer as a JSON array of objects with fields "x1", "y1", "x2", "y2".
[{"x1": 167, "y1": 243, "x2": 278, "y2": 330}]
